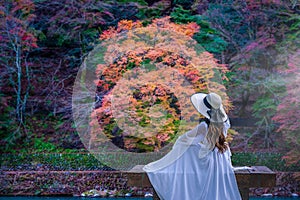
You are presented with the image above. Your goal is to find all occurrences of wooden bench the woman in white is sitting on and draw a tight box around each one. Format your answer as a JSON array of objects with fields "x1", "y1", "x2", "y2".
[{"x1": 126, "y1": 165, "x2": 276, "y2": 200}]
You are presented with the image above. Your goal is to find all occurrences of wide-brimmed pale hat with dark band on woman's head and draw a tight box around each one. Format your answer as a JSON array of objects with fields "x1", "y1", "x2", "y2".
[{"x1": 191, "y1": 93, "x2": 228, "y2": 122}]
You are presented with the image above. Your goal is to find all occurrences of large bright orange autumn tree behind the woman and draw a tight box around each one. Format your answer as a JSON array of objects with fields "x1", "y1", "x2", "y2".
[{"x1": 75, "y1": 17, "x2": 230, "y2": 156}]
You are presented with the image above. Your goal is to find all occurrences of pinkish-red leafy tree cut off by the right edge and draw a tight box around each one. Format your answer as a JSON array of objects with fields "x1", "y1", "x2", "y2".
[{"x1": 272, "y1": 12, "x2": 300, "y2": 166}]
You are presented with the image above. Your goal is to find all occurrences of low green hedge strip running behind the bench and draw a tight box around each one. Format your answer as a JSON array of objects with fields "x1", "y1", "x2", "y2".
[{"x1": 0, "y1": 152, "x2": 299, "y2": 171}]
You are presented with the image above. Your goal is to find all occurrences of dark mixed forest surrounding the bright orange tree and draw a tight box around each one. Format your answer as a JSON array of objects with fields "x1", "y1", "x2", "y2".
[{"x1": 0, "y1": 0, "x2": 300, "y2": 178}]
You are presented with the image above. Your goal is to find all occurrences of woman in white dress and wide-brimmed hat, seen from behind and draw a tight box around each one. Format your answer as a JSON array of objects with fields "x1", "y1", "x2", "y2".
[{"x1": 143, "y1": 93, "x2": 241, "y2": 200}]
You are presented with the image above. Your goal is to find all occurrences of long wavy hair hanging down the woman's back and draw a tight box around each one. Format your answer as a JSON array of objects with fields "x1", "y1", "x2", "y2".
[{"x1": 206, "y1": 122, "x2": 228, "y2": 153}]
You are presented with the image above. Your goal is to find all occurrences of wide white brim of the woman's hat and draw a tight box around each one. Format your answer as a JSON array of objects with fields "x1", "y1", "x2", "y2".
[{"x1": 190, "y1": 93, "x2": 228, "y2": 122}]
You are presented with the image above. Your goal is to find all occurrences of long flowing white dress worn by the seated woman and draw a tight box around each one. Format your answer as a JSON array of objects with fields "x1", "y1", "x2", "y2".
[{"x1": 143, "y1": 120, "x2": 241, "y2": 200}]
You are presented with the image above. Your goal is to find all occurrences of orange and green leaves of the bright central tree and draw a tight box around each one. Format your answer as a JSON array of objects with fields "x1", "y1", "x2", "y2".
[{"x1": 91, "y1": 18, "x2": 229, "y2": 152}]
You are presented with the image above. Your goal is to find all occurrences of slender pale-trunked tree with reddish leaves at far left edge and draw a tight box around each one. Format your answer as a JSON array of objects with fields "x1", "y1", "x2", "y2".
[{"x1": 0, "y1": 0, "x2": 37, "y2": 141}]
